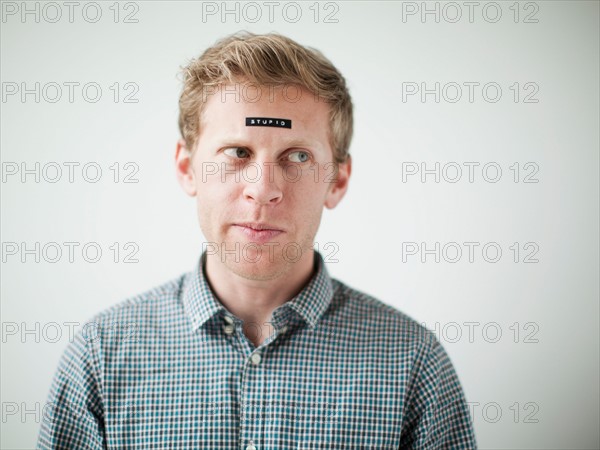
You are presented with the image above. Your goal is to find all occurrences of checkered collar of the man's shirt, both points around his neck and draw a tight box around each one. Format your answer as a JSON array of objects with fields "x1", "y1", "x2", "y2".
[{"x1": 182, "y1": 251, "x2": 333, "y2": 330}]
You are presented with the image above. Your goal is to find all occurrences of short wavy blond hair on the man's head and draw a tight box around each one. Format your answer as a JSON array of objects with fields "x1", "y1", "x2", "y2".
[{"x1": 179, "y1": 32, "x2": 353, "y2": 163}]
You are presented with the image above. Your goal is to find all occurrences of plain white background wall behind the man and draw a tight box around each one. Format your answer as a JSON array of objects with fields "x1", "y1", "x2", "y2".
[{"x1": 0, "y1": 1, "x2": 600, "y2": 449}]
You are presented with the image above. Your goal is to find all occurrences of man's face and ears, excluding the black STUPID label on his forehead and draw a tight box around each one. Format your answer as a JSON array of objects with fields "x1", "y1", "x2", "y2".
[{"x1": 176, "y1": 84, "x2": 350, "y2": 280}]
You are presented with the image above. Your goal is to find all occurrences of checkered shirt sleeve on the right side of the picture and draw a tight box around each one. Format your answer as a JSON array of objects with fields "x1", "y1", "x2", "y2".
[{"x1": 400, "y1": 335, "x2": 477, "y2": 449}]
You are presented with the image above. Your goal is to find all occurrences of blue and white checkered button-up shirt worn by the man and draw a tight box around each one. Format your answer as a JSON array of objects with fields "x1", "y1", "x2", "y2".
[{"x1": 38, "y1": 252, "x2": 476, "y2": 450}]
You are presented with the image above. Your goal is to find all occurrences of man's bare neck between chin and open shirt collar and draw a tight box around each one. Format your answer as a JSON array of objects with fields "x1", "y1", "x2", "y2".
[{"x1": 205, "y1": 251, "x2": 314, "y2": 347}]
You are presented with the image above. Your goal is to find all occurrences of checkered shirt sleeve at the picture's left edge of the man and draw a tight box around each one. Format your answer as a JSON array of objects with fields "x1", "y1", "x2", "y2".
[{"x1": 37, "y1": 326, "x2": 107, "y2": 450}]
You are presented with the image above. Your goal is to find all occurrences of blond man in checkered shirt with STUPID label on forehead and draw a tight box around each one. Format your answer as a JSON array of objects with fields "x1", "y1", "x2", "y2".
[{"x1": 39, "y1": 33, "x2": 476, "y2": 450}]
